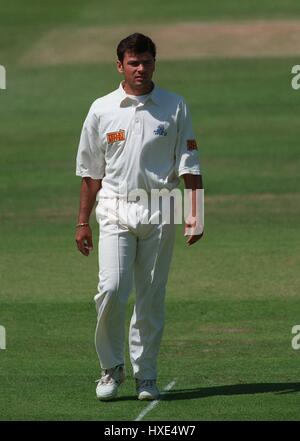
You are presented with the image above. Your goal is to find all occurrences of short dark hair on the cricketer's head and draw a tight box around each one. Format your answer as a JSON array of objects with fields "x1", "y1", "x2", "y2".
[{"x1": 117, "y1": 32, "x2": 156, "y2": 63}]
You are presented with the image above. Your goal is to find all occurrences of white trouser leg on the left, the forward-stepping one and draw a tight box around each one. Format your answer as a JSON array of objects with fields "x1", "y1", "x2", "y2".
[{"x1": 95, "y1": 219, "x2": 136, "y2": 369}]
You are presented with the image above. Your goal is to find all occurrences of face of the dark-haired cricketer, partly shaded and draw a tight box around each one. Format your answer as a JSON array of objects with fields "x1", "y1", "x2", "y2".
[{"x1": 117, "y1": 51, "x2": 155, "y2": 92}]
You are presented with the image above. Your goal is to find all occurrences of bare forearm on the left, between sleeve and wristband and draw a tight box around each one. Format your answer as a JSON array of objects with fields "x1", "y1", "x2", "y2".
[{"x1": 78, "y1": 177, "x2": 101, "y2": 223}]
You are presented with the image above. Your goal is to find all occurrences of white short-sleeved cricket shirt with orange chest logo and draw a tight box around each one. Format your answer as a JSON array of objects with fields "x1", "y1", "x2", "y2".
[{"x1": 76, "y1": 83, "x2": 200, "y2": 197}]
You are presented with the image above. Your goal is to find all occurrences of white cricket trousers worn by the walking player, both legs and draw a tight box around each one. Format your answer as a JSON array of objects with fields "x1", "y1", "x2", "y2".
[{"x1": 94, "y1": 198, "x2": 175, "y2": 380}]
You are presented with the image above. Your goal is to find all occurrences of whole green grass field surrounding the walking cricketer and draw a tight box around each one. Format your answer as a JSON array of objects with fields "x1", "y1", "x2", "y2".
[{"x1": 0, "y1": 0, "x2": 300, "y2": 421}]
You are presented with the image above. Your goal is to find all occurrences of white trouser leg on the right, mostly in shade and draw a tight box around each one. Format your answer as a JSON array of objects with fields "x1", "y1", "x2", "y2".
[{"x1": 129, "y1": 224, "x2": 175, "y2": 380}]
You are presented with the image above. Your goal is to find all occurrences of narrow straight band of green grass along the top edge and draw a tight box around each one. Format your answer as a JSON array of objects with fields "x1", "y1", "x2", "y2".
[{"x1": 0, "y1": 0, "x2": 300, "y2": 26}]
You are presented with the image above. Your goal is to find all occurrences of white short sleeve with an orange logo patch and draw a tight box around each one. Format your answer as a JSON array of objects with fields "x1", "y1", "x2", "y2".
[{"x1": 175, "y1": 101, "x2": 201, "y2": 176}]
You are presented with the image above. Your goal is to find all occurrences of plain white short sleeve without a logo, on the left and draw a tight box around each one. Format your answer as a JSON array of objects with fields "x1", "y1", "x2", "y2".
[{"x1": 76, "y1": 106, "x2": 106, "y2": 179}]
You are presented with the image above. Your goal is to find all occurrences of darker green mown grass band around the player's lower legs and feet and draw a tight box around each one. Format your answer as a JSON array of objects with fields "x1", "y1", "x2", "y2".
[{"x1": 1, "y1": 296, "x2": 300, "y2": 421}]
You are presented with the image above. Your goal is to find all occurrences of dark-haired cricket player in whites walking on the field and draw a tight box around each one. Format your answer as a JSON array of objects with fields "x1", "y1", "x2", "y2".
[{"x1": 76, "y1": 33, "x2": 204, "y2": 400}]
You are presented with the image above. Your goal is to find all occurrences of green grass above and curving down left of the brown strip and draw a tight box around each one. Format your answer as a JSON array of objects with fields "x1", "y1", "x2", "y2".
[{"x1": 0, "y1": 0, "x2": 300, "y2": 67}]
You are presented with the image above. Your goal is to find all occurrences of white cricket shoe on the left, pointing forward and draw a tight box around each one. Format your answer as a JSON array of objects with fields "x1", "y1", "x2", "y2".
[{"x1": 96, "y1": 365, "x2": 125, "y2": 401}]
